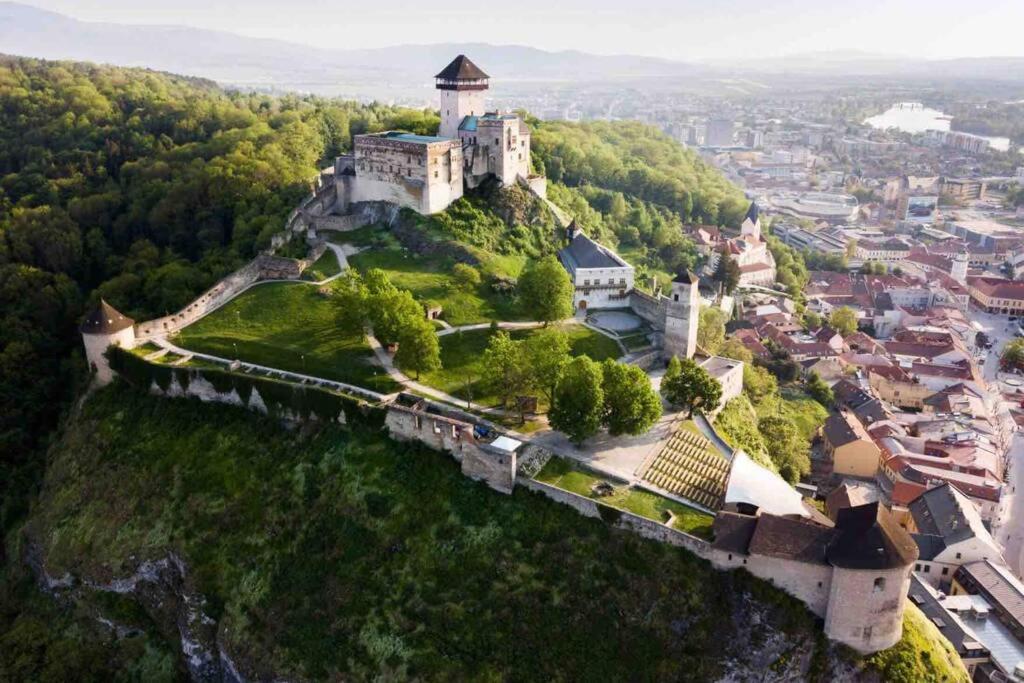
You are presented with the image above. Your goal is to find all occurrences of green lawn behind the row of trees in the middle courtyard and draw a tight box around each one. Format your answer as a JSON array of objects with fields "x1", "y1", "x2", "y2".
[{"x1": 420, "y1": 325, "x2": 621, "y2": 410}]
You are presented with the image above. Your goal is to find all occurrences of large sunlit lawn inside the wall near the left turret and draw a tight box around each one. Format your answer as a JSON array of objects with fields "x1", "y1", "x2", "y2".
[{"x1": 175, "y1": 283, "x2": 396, "y2": 392}]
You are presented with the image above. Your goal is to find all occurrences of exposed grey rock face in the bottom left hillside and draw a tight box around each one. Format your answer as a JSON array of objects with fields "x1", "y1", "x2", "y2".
[{"x1": 25, "y1": 543, "x2": 239, "y2": 683}]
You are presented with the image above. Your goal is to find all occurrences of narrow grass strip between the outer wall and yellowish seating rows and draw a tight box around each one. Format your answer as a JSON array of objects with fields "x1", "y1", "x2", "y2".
[{"x1": 537, "y1": 457, "x2": 714, "y2": 539}]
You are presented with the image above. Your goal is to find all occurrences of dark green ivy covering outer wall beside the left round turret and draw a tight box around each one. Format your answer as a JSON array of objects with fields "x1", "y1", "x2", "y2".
[{"x1": 106, "y1": 346, "x2": 385, "y2": 428}]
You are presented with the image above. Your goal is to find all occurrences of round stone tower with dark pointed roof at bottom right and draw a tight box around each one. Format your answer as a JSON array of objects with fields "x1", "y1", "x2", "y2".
[{"x1": 825, "y1": 503, "x2": 918, "y2": 653}]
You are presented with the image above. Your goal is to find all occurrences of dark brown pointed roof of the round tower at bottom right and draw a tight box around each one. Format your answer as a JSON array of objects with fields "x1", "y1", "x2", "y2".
[{"x1": 826, "y1": 502, "x2": 918, "y2": 569}]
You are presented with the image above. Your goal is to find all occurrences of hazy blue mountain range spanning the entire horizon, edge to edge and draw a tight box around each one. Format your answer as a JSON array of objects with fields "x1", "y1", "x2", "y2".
[{"x1": 0, "y1": 2, "x2": 1024, "y2": 97}]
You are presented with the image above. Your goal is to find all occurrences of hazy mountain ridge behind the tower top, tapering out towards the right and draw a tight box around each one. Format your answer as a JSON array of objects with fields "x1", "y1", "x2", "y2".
[{"x1": 0, "y1": 2, "x2": 697, "y2": 96}]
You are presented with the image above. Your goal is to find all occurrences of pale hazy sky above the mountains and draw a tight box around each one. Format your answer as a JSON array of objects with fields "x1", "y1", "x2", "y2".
[{"x1": 16, "y1": 0, "x2": 1024, "y2": 59}]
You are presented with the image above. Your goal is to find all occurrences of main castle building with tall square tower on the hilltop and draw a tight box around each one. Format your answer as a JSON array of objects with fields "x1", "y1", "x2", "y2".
[{"x1": 334, "y1": 54, "x2": 547, "y2": 214}]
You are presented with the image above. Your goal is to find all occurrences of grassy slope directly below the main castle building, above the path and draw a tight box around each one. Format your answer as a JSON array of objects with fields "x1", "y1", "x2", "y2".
[{"x1": 345, "y1": 241, "x2": 529, "y2": 326}]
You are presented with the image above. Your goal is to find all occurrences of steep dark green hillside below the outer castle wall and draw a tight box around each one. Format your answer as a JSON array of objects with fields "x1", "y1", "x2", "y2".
[{"x1": 6, "y1": 385, "x2": 955, "y2": 681}]
